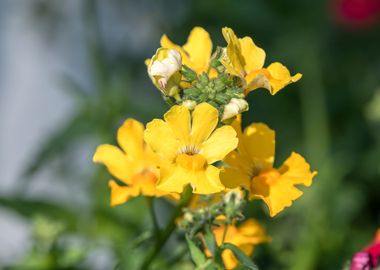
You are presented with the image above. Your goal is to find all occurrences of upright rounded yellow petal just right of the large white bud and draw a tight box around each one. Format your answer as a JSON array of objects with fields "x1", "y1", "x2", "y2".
[{"x1": 183, "y1": 27, "x2": 212, "y2": 73}]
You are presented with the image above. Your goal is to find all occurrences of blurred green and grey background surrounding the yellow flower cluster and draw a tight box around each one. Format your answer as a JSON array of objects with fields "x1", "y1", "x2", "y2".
[{"x1": 0, "y1": 0, "x2": 380, "y2": 270}]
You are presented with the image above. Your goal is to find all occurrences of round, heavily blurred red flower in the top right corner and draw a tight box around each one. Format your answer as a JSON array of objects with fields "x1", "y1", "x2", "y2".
[{"x1": 331, "y1": 0, "x2": 380, "y2": 27}]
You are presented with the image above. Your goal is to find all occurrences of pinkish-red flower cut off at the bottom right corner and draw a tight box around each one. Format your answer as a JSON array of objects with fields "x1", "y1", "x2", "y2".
[{"x1": 350, "y1": 229, "x2": 380, "y2": 270}]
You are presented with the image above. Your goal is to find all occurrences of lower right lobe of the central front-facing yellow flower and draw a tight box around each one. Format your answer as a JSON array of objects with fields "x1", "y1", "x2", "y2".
[{"x1": 190, "y1": 165, "x2": 225, "y2": 194}]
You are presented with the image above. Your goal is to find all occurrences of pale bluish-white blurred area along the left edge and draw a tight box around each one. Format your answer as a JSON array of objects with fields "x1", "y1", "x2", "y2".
[{"x1": 0, "y1": 1, "x2": 84, "y2": 266}]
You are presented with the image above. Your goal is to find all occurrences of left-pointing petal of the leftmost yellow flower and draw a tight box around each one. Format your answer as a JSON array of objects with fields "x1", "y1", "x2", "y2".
[{"x1": 93, "y1": 144, "x2": 135, "y2": 183}]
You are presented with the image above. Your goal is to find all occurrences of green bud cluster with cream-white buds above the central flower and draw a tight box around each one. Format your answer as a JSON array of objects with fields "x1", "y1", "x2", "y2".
[{"x1": 148, "y1": 48, "x2": 249, "y2": 122}]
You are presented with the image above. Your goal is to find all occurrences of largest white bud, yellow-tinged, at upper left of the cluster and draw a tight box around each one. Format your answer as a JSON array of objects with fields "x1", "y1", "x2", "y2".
[{"x1": 148, "y1": 48, "x2": 182, "y2": 96}]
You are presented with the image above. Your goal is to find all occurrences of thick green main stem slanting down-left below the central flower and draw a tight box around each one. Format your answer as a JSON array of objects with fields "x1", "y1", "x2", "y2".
[{"x1": 140, "y1": 186, "x2": 192, "y2": 270}]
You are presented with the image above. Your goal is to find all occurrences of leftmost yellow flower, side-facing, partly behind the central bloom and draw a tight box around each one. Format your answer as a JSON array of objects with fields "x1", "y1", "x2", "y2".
[{"x1": 93, "y1": 119, "x2": 176, "y2": 206}]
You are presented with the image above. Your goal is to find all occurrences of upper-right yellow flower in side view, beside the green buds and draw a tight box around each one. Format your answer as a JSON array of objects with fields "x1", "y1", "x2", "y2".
[{"x1": 221, "y1": 27, "x2": 302, "y2": 95}]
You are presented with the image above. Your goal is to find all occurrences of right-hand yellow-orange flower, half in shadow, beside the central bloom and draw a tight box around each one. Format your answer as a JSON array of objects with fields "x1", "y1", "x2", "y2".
[{"x1": 221, "y1": 118, "x2": 317, "y2": 217}]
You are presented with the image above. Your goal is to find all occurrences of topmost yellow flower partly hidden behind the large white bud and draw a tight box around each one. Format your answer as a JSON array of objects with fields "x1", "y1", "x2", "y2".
[{"x1": 161, "y1": 27, "x2": 212, "y2": 74}]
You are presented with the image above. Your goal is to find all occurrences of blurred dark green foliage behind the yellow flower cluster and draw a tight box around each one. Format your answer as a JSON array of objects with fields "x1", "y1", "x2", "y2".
[{"x1": 0, "y1": 0, "x2": 380, "y2": 270}]
